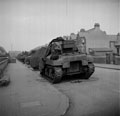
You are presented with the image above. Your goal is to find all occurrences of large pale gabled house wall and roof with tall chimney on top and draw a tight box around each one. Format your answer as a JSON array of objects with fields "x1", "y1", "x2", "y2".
[{"x1": 79, "y1": 23, "x2": 116, "y2": 52}]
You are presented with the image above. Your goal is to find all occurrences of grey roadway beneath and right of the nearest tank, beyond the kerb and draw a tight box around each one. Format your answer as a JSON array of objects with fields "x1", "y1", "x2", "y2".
[{"x1": 54, "y1": 68, "x2": 120, "y2": 116}]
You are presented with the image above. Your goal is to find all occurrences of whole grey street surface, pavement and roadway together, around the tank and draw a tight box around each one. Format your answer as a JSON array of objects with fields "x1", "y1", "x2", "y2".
[{"x1": 0, "y1": 61, "x2": 120, "y2": 116}]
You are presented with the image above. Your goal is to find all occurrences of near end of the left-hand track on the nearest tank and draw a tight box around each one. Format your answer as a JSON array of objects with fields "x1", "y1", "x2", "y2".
[{"x1": 50, "y1": 67, "x2": 62, "y2": 83}]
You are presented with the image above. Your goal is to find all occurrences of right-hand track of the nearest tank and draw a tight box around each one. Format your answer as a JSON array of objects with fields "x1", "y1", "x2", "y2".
[{"x1": 83, "y1": 63, "x2": 95, "y2": 79}]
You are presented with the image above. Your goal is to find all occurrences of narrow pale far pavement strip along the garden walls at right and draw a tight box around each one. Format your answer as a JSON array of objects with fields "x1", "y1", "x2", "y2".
[{"x1": 95, "y1": 63, "x2": 120, "y2": 70}]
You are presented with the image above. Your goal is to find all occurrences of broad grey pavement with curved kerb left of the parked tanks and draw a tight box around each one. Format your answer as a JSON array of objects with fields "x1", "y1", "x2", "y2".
[{"x1": 0, "y1": 61, "x2": 69, "y2": 116}]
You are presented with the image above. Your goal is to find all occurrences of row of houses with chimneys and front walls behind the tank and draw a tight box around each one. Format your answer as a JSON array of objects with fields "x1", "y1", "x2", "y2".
[{"x1": 64, "y1": 23, "x2": 120, "y2": 64}]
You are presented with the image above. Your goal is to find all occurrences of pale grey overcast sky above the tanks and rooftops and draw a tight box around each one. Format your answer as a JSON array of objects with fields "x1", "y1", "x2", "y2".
[{"x1": 0, "y1": 0, "x2": 120, "y2": 51}]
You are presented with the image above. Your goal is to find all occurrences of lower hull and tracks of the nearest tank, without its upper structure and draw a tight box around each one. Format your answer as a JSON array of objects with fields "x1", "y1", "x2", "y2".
[{"x1": 40, "y1": 55, "x2": 95, "y2": 83}]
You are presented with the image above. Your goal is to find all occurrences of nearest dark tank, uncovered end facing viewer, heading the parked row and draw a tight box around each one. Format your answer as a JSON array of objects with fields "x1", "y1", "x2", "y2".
[{"x1": 39, "y1": 35, "x2": 95, "y2": 83}]
